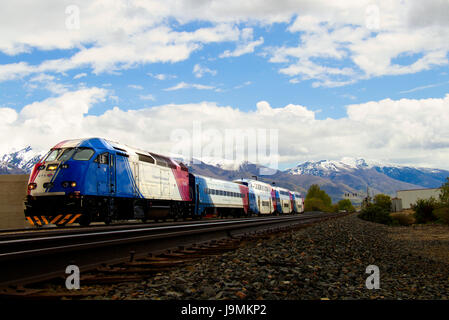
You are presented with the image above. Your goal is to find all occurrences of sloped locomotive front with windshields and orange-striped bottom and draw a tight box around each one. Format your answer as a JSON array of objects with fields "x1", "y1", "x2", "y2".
[{"x1": 25, "y1": 140, "x2": 95, "y2": 226}]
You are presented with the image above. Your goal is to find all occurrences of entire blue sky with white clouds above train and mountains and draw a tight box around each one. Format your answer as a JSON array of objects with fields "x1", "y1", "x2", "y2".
[{"x1": 0, "y1": 0, "x2": 449, "y2": 168}]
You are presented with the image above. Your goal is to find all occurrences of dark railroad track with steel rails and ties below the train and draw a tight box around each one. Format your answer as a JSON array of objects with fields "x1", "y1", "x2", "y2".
[{"x1": 0, "y1": 213, "x2": 343, "y2": 296}]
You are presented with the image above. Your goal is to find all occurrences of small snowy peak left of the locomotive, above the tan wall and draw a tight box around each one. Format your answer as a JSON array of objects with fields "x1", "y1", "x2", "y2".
[{"x1": 0, "y1": 146, "x2": 43, "y2": 173}]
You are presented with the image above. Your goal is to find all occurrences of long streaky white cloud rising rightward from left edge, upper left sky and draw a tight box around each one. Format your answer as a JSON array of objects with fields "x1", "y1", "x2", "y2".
[{"x1": 0, "y1": 20, "x2": 240, "y2": 81}]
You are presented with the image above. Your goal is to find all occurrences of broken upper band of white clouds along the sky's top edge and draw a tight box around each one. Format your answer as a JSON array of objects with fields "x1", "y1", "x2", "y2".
[{"x1": 0, "y1": 0, "x2": 449, "y2": 86}]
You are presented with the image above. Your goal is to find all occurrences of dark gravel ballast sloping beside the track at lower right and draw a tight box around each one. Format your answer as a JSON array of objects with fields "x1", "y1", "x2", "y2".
[{"x1": 86, "y1": 214, "x2": 449, "y2": 300}]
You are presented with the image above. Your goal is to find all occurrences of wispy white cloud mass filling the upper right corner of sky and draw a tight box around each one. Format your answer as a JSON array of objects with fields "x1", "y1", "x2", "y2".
[{"x1": 266, "y1": 0, "x2": 449, "y2": 87}]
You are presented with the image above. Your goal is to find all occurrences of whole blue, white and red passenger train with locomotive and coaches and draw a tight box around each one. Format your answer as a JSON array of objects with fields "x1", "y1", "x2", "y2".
[{"x1": 25, "y1": 138, "x2": 304, "y2": 227}]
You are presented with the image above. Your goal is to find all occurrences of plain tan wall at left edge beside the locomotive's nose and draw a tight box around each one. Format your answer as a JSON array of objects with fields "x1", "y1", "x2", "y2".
[{"x1": 0, "y1": 174, "x2": 30, "y2": 229}]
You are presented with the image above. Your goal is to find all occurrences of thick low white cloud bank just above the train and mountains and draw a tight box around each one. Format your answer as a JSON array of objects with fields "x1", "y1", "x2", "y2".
[{"x1": 0, "y1": 88, "x2": 449, "y2": 169}]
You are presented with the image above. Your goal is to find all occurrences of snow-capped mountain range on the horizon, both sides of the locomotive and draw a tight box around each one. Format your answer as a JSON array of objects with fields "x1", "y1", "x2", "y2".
[{"x1": 0, "y1": 147, "x2": 449, "y2": 203}]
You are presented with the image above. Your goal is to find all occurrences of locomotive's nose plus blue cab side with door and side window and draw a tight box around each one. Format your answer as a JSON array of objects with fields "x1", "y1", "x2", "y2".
[{"x1": 25, "y1": 140, "x2": 115, "y2": 226}]
